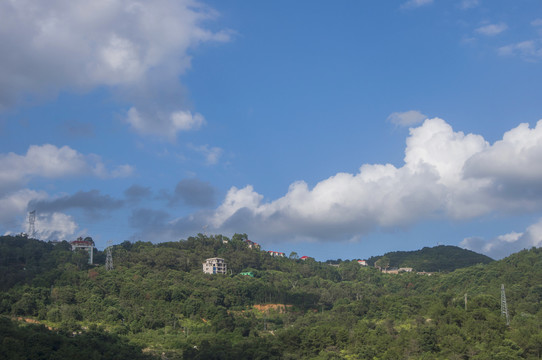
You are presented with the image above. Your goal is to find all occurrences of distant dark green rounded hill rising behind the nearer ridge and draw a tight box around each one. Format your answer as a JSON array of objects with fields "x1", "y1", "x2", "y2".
[{"x1": 368, "y1": 245, "x2": 493, "y2": 272}]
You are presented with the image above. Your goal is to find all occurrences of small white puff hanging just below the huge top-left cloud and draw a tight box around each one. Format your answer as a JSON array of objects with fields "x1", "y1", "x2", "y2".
[{"x1": 126, "y1": 107, "x2": 205, "y2": 140}]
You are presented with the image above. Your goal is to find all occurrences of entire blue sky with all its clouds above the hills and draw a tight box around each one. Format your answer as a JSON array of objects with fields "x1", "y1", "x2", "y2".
[{"x1": 0, "y1": 0, "x2": 542, "y2": 260}]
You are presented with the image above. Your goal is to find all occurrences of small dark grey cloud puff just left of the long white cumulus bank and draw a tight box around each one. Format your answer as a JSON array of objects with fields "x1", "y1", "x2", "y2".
[{"x1": 170, "y1": 178, "x2": 215, "y2": 207}]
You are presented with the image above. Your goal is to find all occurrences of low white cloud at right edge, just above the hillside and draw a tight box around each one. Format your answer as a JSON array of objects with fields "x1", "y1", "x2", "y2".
[{"x1": 461, "y1": 219, "x2": 542, "y2": 259}]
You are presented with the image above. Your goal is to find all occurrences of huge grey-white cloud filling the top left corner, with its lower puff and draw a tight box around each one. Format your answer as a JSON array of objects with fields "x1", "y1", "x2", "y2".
[{"x1": 0, "y1": 0, "x2": 232, "y2": 137}]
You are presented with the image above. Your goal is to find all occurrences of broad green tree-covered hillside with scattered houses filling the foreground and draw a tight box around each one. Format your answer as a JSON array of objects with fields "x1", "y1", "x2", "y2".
[{"x1": 0, "y1": 234, "x2": 542, "y2": 360}]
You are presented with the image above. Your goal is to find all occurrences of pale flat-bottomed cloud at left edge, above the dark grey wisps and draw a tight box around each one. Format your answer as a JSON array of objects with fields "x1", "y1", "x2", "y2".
[{"x1": 0, "y1": 144, "x2": 133, "y2": 193}]
